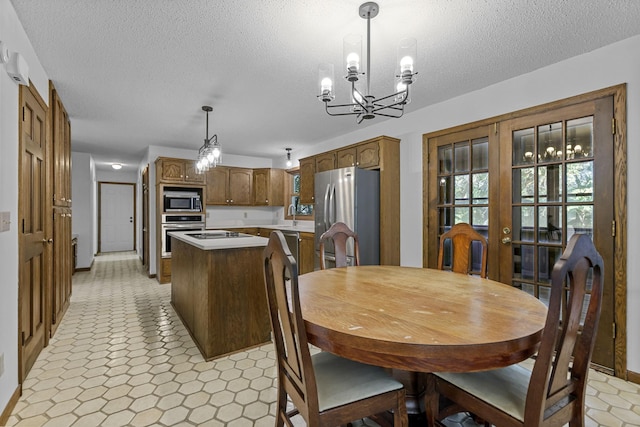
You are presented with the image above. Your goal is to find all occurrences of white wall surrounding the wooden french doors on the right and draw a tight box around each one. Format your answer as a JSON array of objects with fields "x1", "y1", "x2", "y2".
[{"x1": 295, "y1": 36, "x2": 640, "y2": 373}]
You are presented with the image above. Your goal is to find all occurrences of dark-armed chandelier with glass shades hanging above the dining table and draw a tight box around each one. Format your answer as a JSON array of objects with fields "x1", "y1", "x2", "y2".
[{"x1": 318, "y1": 2, "x2": 417, "y2": 123}]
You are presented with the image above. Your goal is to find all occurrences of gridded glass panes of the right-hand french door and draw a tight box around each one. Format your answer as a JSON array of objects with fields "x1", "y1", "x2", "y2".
[{"x1": 511, "y1": 116, "x2": 594, "y2": 303}]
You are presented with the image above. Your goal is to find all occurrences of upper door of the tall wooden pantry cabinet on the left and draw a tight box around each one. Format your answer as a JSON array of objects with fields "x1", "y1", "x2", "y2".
[{"x1": 49, "y1": 82, "x2": 71, "y2": 207}]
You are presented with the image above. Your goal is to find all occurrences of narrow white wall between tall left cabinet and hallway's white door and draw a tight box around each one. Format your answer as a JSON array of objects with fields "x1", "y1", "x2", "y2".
[{"x1": 71, "y1": 152, "x2": 97, "y2": 268}]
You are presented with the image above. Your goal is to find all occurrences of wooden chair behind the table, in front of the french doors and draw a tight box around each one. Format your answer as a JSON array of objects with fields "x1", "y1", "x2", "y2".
[{"x1": 438, "y1": 222, "x2": 487, "y2": 278}]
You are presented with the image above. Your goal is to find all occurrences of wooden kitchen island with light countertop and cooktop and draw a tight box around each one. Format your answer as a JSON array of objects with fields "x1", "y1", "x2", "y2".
[{"x1": 171, "y1": 230, "x2": 271, "y2": 360}]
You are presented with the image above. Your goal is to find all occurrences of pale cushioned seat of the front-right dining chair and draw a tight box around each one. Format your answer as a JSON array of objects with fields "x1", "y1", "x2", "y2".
[{"x1": 434, "y1": 365, "x2": 531, "y2": 421}]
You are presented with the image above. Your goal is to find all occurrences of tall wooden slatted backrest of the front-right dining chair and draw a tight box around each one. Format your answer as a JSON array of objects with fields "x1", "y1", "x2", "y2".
[{"x1": 525, "y1": 234, "x2": 604, "y2": 420}]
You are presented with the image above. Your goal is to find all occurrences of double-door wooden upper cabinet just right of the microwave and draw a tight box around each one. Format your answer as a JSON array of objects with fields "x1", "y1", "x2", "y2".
[{"x1": 206, "y1": 166, "x2": 253, "y2": 206}]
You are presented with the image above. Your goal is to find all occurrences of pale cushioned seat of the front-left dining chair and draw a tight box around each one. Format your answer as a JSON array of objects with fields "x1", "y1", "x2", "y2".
[{"x1": 311, "y1": 352, "x2": 403, "y2": 412}]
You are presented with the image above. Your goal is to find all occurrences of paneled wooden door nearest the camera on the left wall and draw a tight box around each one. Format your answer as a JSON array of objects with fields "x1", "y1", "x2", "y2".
[{"x1": 18, "y1": 85, "x2": 52, "y2": 382}]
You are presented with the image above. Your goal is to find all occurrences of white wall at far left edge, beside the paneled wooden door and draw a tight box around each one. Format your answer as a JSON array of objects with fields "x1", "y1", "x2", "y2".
[{"x1": 0, "y1": 0, "x2": 49, "y2": 412}]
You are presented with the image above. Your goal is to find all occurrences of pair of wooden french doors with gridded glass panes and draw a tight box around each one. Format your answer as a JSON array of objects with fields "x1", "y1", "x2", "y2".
[{"x1": 424, "y1": 88, "x2": 626, "y2": 373}]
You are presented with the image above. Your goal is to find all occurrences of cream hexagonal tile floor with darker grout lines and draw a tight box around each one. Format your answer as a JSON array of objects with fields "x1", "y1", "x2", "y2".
[{"x1": 8, "y1": 252, "x2": 640, "y2": 427}]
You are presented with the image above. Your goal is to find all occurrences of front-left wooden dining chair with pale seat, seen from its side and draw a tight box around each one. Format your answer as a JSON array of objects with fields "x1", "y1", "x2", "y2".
[{"x1": 264, "y1": 231, "x2": 407, "y2": 427}]
